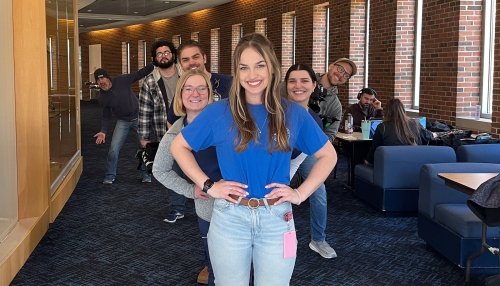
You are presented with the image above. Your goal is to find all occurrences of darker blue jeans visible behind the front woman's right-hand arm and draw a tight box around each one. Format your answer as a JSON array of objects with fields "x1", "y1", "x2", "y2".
[{"x1": 297, "y1": 156, "x2": 328, "y2": 241}]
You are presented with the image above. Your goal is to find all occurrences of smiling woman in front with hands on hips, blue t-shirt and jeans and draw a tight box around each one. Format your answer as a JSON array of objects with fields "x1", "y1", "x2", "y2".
[{"x1": 171, "y1": 33, "x2": 337, "y2": 286}]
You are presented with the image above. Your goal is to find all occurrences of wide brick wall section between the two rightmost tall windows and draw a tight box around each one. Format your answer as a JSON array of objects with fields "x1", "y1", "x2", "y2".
[{"x1": 420, "y1": 0, "x2": 481, "y2": 125}]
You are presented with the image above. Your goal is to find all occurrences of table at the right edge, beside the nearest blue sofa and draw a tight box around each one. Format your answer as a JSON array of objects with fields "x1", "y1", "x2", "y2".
[{"x1": 438, "y1": 173, "x2": 498, "y2": 195}]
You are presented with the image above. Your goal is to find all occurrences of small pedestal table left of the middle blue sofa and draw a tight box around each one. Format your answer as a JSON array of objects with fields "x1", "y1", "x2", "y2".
[{"x1": 334, "y1": 132, "x2": 372, "y2": 187}]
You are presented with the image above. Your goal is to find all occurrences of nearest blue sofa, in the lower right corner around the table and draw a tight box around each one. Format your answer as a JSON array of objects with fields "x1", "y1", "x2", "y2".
[{"x1": 417, "y1": 162, "x2": 500, "y2": 273}]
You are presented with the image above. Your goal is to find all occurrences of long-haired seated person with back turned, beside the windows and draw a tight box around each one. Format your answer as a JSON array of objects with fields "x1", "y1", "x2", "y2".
[{"x1": 365, "y1": 98, "x2": 434, "y2": 164}]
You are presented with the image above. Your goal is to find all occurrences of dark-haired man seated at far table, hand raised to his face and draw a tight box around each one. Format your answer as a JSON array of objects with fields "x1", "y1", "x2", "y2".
[{"x1": 340, "y1": 87, "x2": 384, "y2": 132}]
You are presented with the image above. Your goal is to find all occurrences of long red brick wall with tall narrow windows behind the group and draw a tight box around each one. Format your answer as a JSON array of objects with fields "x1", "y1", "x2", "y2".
[{"x1": 80, "y1": 0, "x2": 500, "y2": 137}]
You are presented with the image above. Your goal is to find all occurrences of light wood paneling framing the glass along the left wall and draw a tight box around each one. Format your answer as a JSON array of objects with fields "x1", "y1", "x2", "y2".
[{"x1": 0, "y1": 0, "x2": 82, "y2": 285}]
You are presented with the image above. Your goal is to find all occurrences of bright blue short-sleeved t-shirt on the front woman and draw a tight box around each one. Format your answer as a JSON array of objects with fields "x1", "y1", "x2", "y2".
[{"x1": 182, "y1": 99, "x2": 328, "y2": 198}]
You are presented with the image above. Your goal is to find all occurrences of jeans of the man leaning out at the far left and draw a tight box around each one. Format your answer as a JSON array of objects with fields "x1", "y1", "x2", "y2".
[{"x1": 106, "y1": 119, "x2": 146, "y2": 180}]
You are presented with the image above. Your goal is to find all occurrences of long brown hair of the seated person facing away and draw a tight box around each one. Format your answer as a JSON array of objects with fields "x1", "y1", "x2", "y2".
[{"x1": 384, "y1": 98, "x2": 419, "y2": 145}]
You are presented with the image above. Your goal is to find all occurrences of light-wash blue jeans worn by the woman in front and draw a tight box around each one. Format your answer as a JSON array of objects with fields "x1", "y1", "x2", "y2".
[{"x1": 208, "y1": 199, "x2": 297, "y2": 286}]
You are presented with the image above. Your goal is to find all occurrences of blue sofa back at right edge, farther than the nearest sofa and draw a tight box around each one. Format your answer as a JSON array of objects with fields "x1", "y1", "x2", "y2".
[{"x1": 457, "y1": 144, "x2": 500, "y2": 164}]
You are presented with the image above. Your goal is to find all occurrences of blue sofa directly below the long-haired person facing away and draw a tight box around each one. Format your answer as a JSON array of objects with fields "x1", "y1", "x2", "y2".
[{"x1": 354, "y1": 146, "x2": 456, "y2": 215}]
